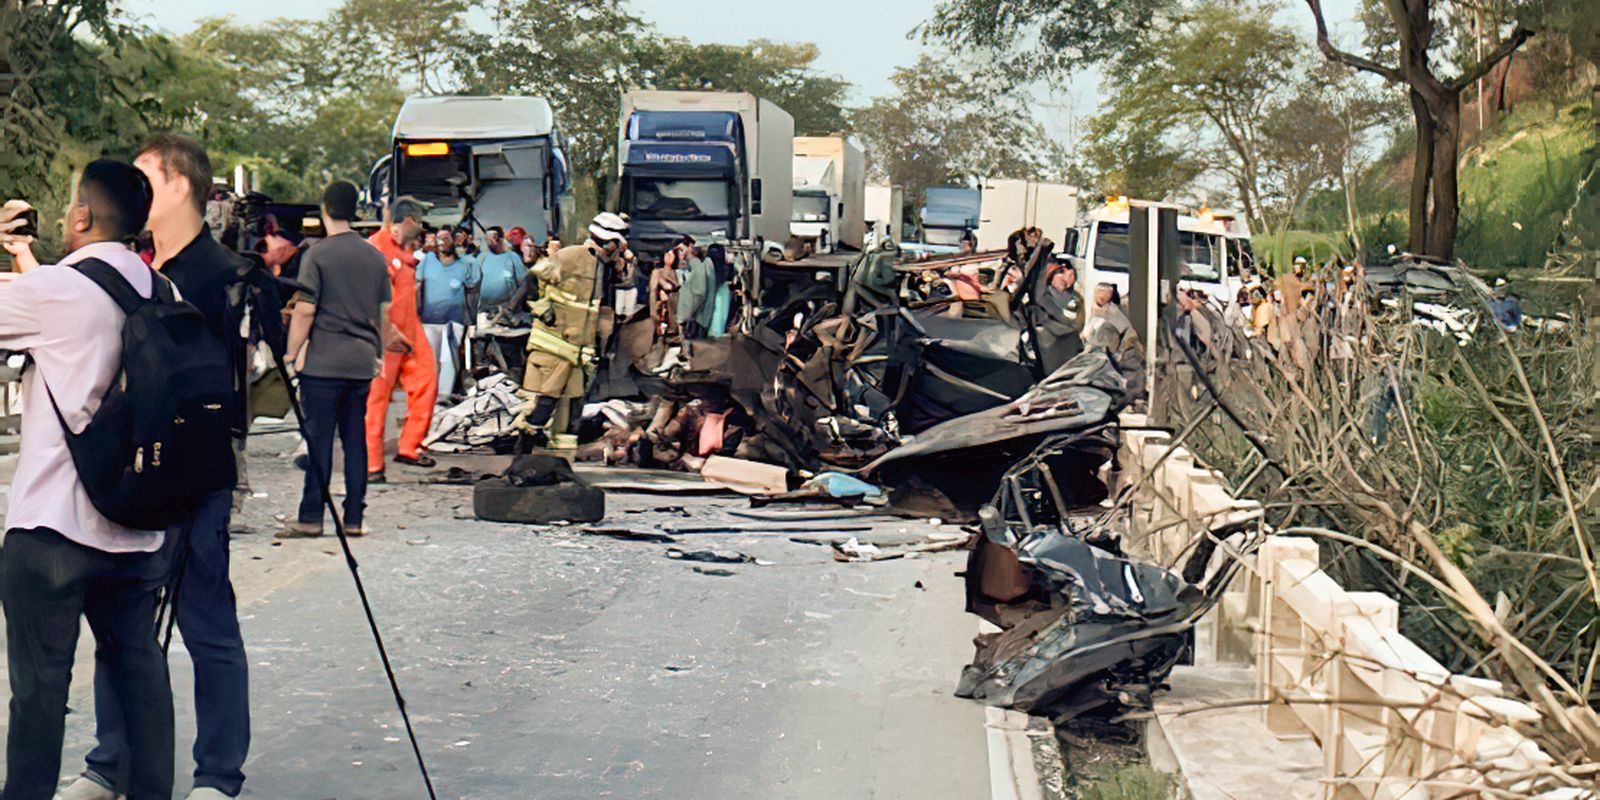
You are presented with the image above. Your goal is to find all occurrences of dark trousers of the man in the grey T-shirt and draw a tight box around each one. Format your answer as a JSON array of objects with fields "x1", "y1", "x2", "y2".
[{"x1": 298, "y1": 374, "x2": 373, "y2": 528}]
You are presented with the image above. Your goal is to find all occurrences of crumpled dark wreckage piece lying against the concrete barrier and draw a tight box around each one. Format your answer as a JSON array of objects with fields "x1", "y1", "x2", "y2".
[{"x1": 957, "y1": 419, "x2": 1251, "y2": 723}]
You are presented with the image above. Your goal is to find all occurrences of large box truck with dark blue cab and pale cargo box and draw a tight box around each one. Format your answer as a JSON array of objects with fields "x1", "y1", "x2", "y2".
[{"x1": 616, "y1": 91, "x2": 795, "y2": 256}]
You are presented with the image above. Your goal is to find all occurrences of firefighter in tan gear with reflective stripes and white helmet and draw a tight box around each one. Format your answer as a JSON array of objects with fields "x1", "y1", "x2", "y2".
[{"x1": 514, "y1": 213, "x2": 627, "y2": 446}]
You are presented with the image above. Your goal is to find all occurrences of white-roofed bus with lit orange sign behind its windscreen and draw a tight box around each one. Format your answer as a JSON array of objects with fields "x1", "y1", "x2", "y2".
[{"x1": 366, "y1": 96, "x2": 573, "y2": 242}]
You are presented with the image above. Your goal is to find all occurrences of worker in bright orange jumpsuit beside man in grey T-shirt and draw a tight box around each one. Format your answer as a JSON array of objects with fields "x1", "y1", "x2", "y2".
[{"x1": 366, "y1": 198, "x2": 438, "y2": 483}]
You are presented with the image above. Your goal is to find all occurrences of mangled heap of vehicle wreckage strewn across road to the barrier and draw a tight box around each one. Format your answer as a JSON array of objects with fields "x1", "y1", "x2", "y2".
[{"x1": 422, "y1": 230, "x2": 1237, "y2": 720}]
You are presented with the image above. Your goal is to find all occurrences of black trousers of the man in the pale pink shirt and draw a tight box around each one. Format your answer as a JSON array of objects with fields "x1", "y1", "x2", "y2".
[{"x1": 0, "y1": 528, "x2": 173, "y2": 800}]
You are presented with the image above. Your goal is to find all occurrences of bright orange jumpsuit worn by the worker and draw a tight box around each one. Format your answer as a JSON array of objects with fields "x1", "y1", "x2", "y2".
[{"x1": 366, "y1": 227, "x2": 438, "y2": 472}]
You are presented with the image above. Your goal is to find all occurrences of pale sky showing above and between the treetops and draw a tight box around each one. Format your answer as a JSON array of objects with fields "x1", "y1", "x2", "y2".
[{"x1": 123, "y1": 0, "x2": 1358, "y2": 144}]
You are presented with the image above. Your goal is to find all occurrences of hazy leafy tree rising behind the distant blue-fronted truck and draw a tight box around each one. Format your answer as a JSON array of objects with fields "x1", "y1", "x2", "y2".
[{"x1": 850, "y1": 54, "x2": 1064, "y2": 214}]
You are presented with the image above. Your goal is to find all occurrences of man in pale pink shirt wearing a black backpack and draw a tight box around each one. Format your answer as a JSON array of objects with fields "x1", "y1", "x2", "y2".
[{"x1": 0, "y1": 160, "x2": 173, "y2": 800}]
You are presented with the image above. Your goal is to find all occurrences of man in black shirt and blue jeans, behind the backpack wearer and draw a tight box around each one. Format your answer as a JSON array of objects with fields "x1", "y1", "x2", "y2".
[{"x1": 50, "y1": 134, "x2": 250, "y2": 800}]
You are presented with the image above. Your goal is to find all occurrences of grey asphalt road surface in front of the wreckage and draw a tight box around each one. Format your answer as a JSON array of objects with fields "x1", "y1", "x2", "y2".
[{"x1": 0, "y1": 435, "x2": 989, "y2": 800}]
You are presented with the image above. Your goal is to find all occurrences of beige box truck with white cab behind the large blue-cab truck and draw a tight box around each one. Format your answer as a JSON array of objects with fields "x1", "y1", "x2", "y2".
[{"x1": 789, "y1": 136, "x2": 867, "y2": 253}]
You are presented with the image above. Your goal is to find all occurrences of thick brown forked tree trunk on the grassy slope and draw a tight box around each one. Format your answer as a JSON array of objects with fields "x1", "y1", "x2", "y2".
[{"x1": 1306, "y1": 0, "x2": 1533, "y2": 259}]
